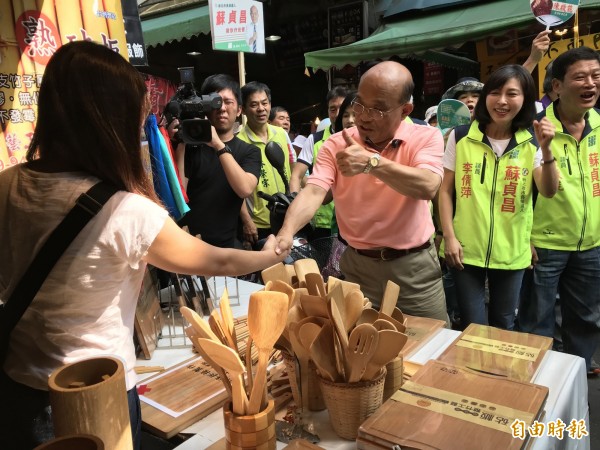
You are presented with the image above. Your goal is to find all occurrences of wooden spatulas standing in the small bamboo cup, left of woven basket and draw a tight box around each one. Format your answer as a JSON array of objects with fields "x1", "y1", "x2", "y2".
[{"x1": 180, "y1": 290, "x2": 290, "y2": 415}]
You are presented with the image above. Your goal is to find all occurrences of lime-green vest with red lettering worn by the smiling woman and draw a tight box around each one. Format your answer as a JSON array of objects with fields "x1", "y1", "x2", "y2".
[{"x1": 442, "y1": 121, "x2": 537, "y2": 270}]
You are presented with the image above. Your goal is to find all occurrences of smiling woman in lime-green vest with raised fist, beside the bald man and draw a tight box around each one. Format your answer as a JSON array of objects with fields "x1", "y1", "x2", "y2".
[{"x1": 439, "y1": 65, "x2": 558, "y2": 330}]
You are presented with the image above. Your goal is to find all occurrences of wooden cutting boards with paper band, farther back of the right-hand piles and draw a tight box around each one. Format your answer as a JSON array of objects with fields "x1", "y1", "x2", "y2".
[{"x1": 438, "y1": 324, "x2": 552, "y2": 381}]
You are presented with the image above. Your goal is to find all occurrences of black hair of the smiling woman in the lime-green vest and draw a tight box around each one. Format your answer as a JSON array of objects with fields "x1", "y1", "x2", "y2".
[{"x1": 473, "y1": 64, "x2": 536, "y2": 133}]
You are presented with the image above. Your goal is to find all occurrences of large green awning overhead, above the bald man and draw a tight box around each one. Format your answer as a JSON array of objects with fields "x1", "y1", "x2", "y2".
[{"x1": 304, "y1": 0, "x2": 600, "y2": 70}]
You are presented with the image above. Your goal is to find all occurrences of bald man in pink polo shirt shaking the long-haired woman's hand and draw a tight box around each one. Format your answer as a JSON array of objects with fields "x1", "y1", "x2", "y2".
[{"x1": 277, "y1": 61, "x2": 448, "y2": 322}]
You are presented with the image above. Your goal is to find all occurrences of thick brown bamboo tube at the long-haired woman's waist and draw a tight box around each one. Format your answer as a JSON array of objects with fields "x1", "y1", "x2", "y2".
[{"x1": 48, "y1": 357, "x2": 133, "y2": 450}]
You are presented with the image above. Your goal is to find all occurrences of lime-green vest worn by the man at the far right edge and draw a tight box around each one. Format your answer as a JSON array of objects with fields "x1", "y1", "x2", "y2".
[{"x1": 531, "y1": 105, "x2": 600, "y2": 251}]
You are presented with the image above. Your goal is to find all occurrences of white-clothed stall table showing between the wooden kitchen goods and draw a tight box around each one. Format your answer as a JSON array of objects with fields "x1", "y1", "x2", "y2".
[{"x1": 138, "y1": 278, "x2": 590, "y2": 450}]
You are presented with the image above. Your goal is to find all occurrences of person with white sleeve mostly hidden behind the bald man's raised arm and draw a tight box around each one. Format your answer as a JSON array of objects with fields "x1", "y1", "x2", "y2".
[{"x1": 290, "y1": 86, "x2": 348, "y2": 240}]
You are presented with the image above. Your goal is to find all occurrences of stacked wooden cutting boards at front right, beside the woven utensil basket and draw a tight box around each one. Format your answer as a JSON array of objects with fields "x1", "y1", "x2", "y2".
[{"x1": 357, "y1": 361, "x2": 548, "y2": 450}]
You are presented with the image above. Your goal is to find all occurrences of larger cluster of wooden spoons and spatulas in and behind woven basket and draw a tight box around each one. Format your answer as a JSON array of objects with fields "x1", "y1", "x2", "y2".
[{"x1": 262, "y1": 259, "x2": 408, "y2": 407}]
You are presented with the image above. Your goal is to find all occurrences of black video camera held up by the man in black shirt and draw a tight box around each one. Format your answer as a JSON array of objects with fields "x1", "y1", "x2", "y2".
[{"x1": 164, "y1": 67, "x2": 223, "y2": 145}]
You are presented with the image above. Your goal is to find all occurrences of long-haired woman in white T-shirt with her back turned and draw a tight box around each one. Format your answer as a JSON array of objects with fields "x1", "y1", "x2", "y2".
[{"x1": 0, "y1": 41, "x2": 283, "y2": 449}]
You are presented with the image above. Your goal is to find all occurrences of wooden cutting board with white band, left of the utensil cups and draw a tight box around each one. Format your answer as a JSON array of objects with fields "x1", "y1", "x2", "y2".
[{"x1": 138, "y1": 356, "x2": 228, "y2": 439}]
